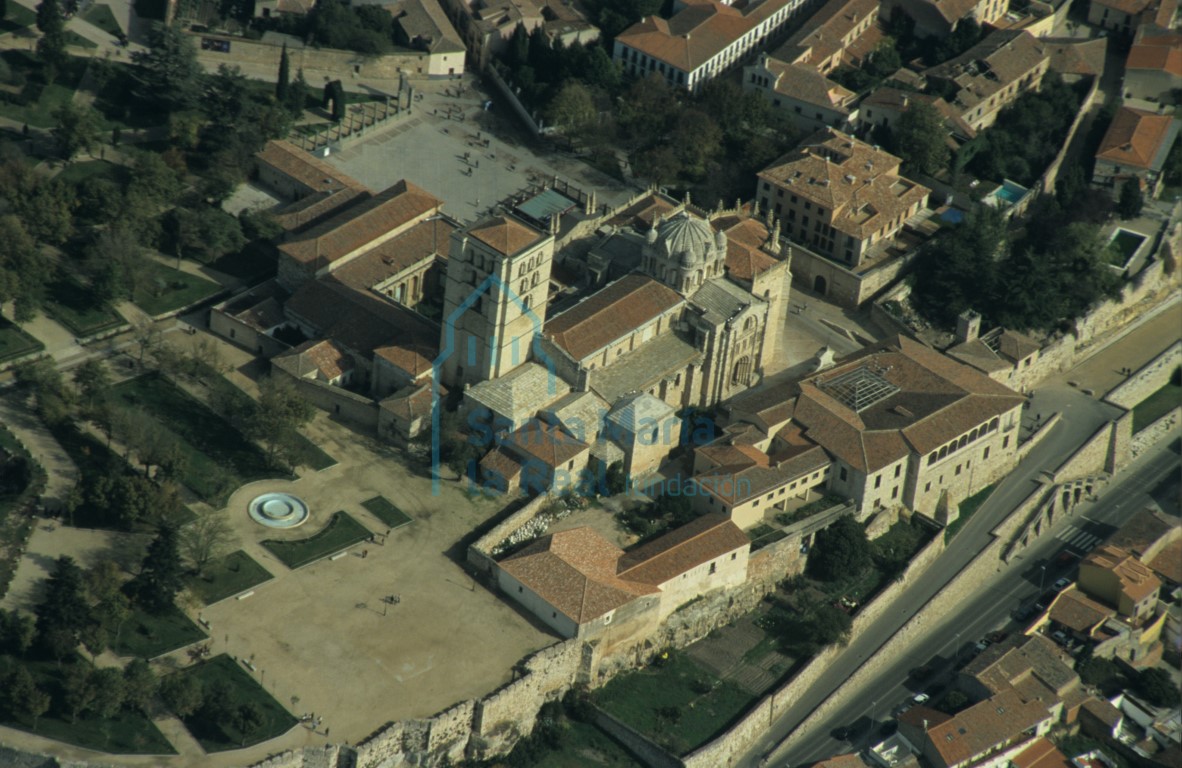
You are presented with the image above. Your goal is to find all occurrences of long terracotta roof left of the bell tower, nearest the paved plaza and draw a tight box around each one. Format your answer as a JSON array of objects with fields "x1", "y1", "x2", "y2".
[{"x1": 279, "y1": 180, "x2": 443, "y2": 265}]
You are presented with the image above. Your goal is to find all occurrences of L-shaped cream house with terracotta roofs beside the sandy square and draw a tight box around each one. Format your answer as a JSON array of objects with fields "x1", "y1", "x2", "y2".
[{"x1": 496, "y1": 515, "x2": 751, "y2": 645}]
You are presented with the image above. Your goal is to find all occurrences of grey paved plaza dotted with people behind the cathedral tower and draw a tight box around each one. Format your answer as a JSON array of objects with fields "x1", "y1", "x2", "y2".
[{"x1": 327, "y1": 77, "x2": 636, "y2": 223}]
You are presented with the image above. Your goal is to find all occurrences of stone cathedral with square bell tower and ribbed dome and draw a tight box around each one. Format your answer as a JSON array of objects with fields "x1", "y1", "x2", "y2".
[{"x1": 440, "y1": 193, "x2": 791, "y2": 490}]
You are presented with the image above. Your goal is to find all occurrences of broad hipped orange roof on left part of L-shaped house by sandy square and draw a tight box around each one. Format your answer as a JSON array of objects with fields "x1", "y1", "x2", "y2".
[{"x1": 500, "y1": 527, "x2": 658, "y2": 624}]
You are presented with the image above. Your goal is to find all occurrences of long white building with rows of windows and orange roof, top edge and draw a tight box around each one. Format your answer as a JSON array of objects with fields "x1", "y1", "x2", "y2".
[{"x1": 612, "y1": 0, "x2": 805, "y2": 93}]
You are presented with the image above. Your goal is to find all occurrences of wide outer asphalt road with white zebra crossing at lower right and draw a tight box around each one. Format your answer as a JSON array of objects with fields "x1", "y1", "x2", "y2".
[{"x1": 771, "y1": 440, "x2": 1182, "y2": 766}]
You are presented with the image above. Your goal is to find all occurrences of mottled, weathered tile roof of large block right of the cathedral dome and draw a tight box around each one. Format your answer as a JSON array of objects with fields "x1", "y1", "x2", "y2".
[{"x1": 759, "y1": 128, "x2": 931, "y2": 240}]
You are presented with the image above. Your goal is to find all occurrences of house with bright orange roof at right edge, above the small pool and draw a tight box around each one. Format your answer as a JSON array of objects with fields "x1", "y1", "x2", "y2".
[{"x1": 1092, "y1": 106, "x2": 1182, "y2": 197}]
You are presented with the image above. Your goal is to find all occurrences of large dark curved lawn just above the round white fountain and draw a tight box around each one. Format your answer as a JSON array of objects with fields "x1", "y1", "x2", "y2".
[{"x1": 111, "y1": 375, "x2": 277, "y2": 506}]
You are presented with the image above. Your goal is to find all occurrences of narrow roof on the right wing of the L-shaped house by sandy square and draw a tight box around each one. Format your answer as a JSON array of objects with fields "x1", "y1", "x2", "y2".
[{"x1": 616, "y1": 514, "x2": 751, "y2": 586}]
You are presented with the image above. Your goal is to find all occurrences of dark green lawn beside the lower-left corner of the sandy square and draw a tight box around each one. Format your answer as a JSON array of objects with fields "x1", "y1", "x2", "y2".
[{"x1": 176, "y1": 653, "x2": 298, "y2": 753}]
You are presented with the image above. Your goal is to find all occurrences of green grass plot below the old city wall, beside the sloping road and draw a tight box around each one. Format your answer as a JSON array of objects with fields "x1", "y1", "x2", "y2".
[{"x1": 595, "y1": 653, "x2": 756, "y2": 755}]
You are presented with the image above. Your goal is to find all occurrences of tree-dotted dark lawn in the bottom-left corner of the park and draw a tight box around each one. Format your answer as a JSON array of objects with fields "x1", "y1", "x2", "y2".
[{"x1": 0, "y1": 657, "x2": 176, "y2": 755}]
